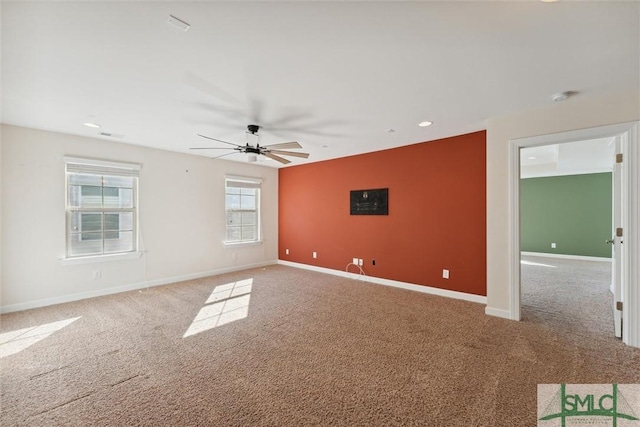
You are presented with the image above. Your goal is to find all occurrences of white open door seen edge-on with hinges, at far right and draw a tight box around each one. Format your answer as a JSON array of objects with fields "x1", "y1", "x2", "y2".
[{"x1": 608, "y1": 135, "x2": 624, "y2": 338}]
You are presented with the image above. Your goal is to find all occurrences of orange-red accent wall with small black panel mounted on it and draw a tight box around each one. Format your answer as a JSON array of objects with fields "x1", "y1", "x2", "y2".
[{"x1": 278, "y1": 131, "x2": 487, "y2": 295}]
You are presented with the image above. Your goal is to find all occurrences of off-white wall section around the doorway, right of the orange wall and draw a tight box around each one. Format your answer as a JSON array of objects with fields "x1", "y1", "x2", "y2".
[{"x1": 487, "y1": 92, "x2": 640, "y2": 317}]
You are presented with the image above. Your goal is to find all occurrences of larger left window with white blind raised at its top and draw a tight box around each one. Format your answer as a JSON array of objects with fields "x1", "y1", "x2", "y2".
[{"x1": 65, "y1": 157, "x2": 140, "y2": 258}]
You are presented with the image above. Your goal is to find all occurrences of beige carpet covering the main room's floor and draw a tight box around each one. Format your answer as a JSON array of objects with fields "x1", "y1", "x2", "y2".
[{"x1": 0, "y1": 266, "x2": 640, "y2": 426}]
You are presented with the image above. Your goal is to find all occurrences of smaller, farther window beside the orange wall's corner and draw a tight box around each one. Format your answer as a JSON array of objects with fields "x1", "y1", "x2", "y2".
[{"x1": 225, "y1": 177, "x2": 261, "y2": 243}]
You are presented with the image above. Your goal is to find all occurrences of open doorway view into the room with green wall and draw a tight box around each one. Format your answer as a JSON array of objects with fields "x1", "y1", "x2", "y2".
[{"x1": 520, "y1": 137, "x2": 621, "y2": 338}]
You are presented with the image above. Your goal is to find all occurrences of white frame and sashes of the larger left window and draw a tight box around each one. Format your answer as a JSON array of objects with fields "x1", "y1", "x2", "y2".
[{"x1": 63, "y1": 156, "x2": 141, "y2": 261}]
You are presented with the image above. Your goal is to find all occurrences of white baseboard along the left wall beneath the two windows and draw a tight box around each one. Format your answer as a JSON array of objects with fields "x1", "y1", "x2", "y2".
[{"x1": 0, "y1": 261, "x2": 276, "y2": 313}]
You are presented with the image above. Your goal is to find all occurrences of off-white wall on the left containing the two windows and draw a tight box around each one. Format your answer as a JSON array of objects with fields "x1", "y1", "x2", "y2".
[{"x1": 0, "y1": 125, "x2": 278, "y2": 311}]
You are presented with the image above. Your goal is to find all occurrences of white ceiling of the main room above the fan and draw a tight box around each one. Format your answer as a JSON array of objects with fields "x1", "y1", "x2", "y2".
[{"x1": 1, "y1": 0, "x2": 640, "y2": 167}]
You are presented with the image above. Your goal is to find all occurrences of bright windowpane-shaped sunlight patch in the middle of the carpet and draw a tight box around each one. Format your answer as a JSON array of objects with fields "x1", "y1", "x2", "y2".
[{"x1": 182, "y1": 278, "x2": 253, "y2": 338}]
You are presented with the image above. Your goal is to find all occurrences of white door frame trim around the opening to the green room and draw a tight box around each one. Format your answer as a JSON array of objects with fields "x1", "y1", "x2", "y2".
[{"x1": 509, "y1": 122, "x2": 640, "y2": 347}]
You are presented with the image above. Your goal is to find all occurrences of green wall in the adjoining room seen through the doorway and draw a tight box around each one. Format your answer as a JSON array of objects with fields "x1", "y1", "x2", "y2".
[{"x1": 520, "y1": 172, "x2": 612, "y2": 258}]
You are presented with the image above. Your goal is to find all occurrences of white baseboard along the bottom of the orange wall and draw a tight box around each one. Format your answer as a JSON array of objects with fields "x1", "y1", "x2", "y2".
[{"x1": 278, "y1": 260, "x2": 487, "y2": 304}]
